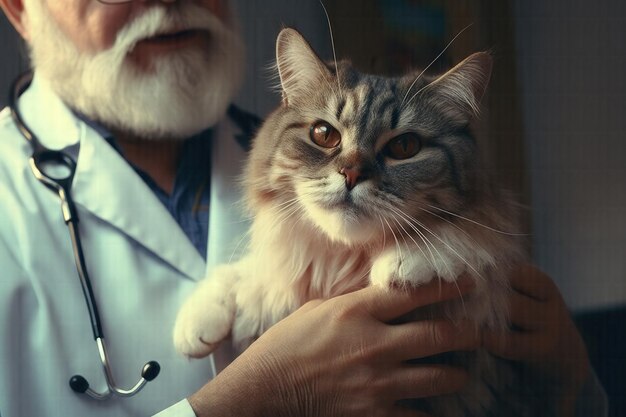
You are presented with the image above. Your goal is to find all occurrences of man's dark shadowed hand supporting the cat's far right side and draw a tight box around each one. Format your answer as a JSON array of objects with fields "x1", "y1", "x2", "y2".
[{"x1": 483, "y1": 265, "x2": 590, "y2": 416}]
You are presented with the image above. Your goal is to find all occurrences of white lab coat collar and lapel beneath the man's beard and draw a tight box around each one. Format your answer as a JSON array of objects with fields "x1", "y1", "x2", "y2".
[{"x1": 19, "y1": 76, "x2": 212, "y2": 280}]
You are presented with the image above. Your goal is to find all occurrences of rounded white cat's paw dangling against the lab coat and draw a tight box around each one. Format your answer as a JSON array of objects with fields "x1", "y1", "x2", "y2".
[{"x1": 174, "y1": 298, "x2": 233, "y2": 358}]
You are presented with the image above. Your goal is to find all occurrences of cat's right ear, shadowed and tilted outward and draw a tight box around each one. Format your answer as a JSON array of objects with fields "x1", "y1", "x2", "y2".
[{"x1": 429, "y1": 52, "x2": 493, "y2": 122}]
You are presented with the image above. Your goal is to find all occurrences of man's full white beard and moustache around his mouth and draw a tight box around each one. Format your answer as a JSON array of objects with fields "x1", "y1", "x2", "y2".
[{"x1": 24, "y1": 0, "x2": 244, "y2": 139}]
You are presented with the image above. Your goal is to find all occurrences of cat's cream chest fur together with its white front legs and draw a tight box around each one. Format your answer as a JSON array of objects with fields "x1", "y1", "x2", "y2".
[{"x1": 174, "y1": 195, "x2": 522, "y2": 357}]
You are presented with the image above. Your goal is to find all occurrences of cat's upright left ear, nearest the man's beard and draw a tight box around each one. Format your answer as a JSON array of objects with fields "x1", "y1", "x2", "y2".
[{"x1": 276, "y1": 28, "x2": 332, "y2": 105}]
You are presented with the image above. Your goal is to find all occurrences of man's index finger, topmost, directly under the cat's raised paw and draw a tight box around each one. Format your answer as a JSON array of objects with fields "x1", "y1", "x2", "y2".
[{"x1": 360, "y1": 276, "x2": 474, "y2": 322}]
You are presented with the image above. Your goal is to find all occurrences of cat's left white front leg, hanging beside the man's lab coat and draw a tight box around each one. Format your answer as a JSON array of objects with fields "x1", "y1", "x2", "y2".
[{"x1": 174, "y1": 265, "x2": 239, "y2": 358}]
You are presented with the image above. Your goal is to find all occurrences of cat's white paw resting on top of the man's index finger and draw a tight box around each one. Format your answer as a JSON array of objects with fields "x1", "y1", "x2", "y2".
[{"x1": 370, "y1": 245, "x2": 465, "y2": 288}]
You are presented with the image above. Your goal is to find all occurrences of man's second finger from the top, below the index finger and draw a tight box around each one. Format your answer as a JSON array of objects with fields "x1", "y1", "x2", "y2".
[{"x1": 387, "y1": 319, "x2": 481, "y2": 360}]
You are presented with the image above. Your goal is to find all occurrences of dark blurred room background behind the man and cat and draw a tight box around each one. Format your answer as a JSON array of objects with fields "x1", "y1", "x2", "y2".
[{"x1": 0, "y1": 0, "x2": 626, "y2": 417}]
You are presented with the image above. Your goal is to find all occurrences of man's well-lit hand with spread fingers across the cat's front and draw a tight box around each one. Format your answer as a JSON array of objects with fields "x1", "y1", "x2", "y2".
[{"x1": 189, "y1": 280, "x2": 480, "y2": 417}]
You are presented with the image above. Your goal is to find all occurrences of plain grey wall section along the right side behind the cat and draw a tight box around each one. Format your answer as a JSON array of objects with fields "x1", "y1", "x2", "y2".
[{"x1": 514, "y1": 0, "x2": 626, "y2": 310}]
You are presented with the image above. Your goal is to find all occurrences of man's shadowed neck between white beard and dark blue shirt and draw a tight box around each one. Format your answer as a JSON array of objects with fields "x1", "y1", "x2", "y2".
[{"x1": 116, "y1": 135, "x2": 184, "y2": 194}]
